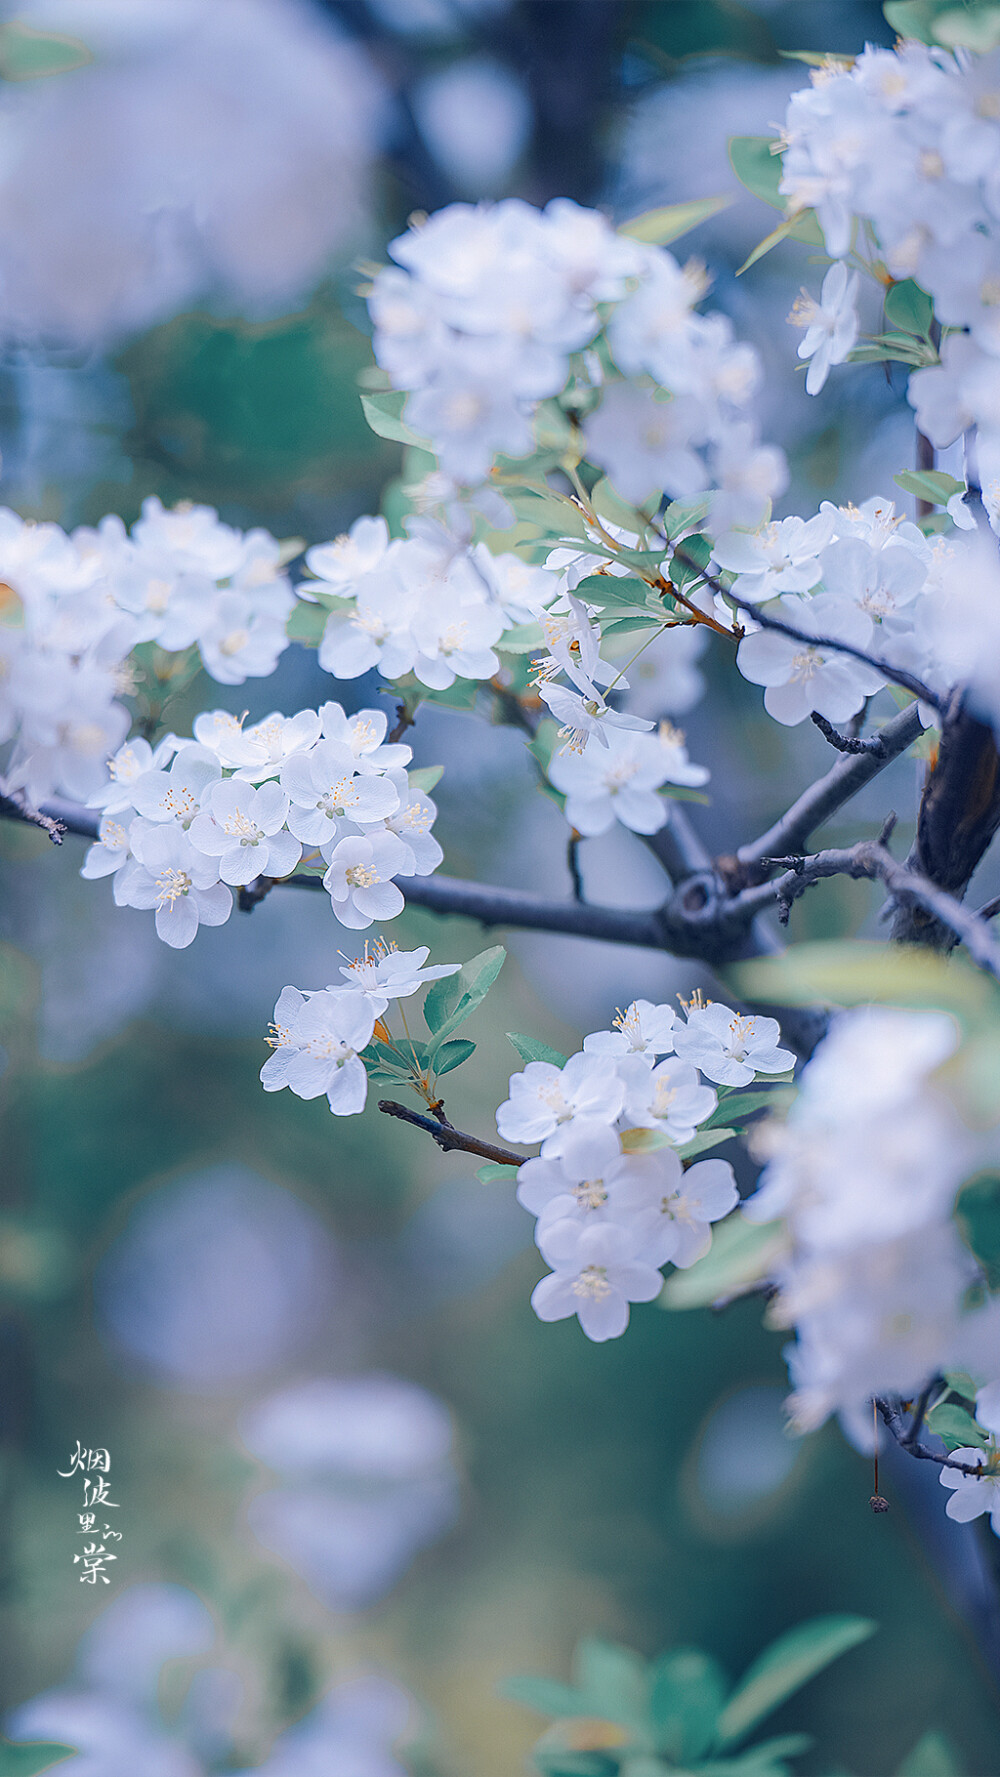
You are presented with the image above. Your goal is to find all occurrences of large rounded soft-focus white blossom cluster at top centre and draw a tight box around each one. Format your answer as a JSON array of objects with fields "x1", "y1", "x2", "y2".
[{"x1": 369, "y1": 199, "x2": 787, "y2": 522}]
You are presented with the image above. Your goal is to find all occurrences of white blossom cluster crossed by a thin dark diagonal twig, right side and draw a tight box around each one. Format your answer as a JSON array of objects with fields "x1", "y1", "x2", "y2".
[{"x1": 714, "y1": 496, "x2": 956, "y2": 727}]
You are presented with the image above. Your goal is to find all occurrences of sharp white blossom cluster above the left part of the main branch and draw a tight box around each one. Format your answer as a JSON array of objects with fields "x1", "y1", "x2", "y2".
[{"x1": 82, "y1": 704, "x2": 442, "y2": 949}]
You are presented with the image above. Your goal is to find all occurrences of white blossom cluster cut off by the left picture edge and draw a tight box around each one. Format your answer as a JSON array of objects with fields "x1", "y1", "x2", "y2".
[{"x1": 0, "y1": 499, "x2": 295, "y2": 807}]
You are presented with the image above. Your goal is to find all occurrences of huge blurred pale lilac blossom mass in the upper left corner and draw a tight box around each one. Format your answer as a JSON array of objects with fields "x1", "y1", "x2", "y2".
[{"x1": 0, "y1": 0, "x2": 384, "y2": 345}]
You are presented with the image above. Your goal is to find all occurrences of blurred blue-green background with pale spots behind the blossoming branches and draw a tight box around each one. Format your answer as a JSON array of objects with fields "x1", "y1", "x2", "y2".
[{"x1": 0, "y1": 0, "x2": 998, "y2": 1777}]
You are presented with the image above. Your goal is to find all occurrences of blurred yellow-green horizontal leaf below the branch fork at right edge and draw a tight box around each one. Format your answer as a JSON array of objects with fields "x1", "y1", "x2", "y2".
[{"x1": 725, "y1": 938, "x2": 996, "y2": 1024}]
